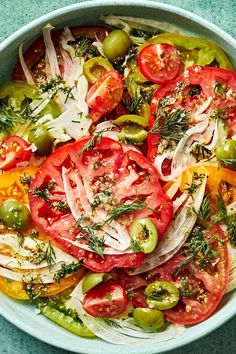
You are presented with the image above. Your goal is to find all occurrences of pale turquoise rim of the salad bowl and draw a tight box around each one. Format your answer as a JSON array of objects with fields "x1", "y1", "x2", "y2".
[{"x1": 0, "y1": 0, "x2": 236, "y2": 354}]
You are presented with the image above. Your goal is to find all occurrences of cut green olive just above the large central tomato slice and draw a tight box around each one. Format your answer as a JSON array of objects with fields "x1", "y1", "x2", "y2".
[{"x1": 118, "y1": 124, "x2": 147, "y2": 144}]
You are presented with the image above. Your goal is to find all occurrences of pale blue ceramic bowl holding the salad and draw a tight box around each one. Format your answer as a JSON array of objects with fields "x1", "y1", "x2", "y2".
[{"x1": 0, "y1": 0, "x2": 236, "y2": 354}]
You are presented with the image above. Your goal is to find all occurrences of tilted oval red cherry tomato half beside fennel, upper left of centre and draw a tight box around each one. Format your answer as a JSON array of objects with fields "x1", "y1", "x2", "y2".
[{"x1": 86, "y1": 70, "x2": 123, "y2": 114}]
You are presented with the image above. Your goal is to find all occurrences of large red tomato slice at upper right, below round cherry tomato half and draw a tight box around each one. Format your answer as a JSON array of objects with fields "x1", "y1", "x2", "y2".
[{"x1": 148, "y1": 65, "x2": 236, "y2": 161}]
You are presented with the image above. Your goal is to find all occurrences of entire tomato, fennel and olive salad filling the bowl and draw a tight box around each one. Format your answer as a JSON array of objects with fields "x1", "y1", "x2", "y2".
[{"x1": 0, "y1": 15, "x2": 236, "y2": 345}]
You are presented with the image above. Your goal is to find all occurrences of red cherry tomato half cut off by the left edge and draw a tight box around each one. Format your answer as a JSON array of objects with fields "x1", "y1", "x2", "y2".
[{"x1": 0, "y1": 135, "x2": 32, "y2": 171}]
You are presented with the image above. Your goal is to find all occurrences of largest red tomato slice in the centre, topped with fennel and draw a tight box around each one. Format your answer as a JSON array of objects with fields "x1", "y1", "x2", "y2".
[{"x1": 29, "y1": 138, "x2": 172, "y2": 272}]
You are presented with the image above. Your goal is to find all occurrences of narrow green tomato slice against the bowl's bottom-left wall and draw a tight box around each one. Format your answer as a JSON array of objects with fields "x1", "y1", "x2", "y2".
[{"x1": 40, "y1": 306, "x2": 95, "y2": 338}]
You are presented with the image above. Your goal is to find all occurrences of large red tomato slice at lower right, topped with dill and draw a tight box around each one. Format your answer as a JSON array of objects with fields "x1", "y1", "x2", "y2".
[{"x1": 151, "y1": 225, "x2": 228, "y2": 324}]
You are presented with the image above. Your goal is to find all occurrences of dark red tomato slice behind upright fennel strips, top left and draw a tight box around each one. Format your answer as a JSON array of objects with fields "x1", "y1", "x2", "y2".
[{"x1": 12, "y1": 26, "x2": 109, "y2": 81}]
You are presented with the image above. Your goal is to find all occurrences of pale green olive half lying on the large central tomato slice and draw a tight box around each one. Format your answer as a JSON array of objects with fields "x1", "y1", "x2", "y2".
[{"x1": 130, "y1": 218, "x2": 158, "y2": 253}]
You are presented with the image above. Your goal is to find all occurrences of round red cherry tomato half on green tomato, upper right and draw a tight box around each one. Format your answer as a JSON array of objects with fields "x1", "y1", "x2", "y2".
[{"x1": 138, "y1": 43, "x2": 180, "y2": 84}]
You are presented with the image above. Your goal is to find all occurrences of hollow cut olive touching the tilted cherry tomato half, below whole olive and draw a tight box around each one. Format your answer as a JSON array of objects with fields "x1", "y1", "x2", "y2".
[{"x1": 83, "y1": 57, "x2": 114, "y2": 84}]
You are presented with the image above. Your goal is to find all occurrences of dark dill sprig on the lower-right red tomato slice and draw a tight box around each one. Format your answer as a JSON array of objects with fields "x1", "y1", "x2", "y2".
[{"x1": 172, "y1": 226, "x2": 218, "y2": 278}]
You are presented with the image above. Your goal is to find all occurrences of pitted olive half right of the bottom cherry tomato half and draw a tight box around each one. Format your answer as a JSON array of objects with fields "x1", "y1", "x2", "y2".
[{"x1": 145, "y1": 281, "x2": 179, "y2": 310}]
